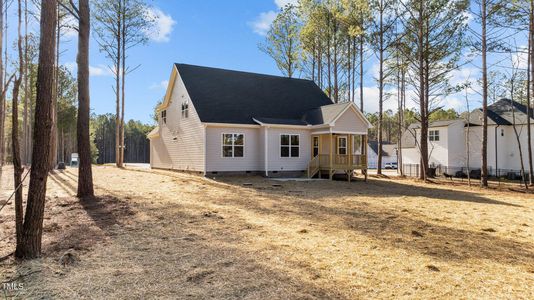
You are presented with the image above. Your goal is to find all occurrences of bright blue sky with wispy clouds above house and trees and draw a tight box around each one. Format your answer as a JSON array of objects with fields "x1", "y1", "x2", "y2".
[{"x1": 4, "y1": 0, "x2": 526, "y2": 122}]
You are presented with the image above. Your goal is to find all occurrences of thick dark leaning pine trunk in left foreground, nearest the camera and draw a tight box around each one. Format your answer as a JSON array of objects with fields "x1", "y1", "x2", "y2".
[{"x1": 15, "y1": 0, "x2": 57, "y2": 259}]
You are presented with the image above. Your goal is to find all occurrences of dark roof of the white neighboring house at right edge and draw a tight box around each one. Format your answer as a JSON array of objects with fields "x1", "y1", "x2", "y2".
[{"x1": 470, "y1": 99, "x2": 534, "y2": 125}]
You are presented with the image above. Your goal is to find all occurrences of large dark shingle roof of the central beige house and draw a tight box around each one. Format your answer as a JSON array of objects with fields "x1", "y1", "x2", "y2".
[{"x1": 176, "y1": 64, "x2": 333, "y2": 125}]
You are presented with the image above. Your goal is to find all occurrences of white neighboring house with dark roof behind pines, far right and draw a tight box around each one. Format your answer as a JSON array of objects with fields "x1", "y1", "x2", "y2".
[{"x1": 402, "y1": 99, "x2": 534, "y2": 175}]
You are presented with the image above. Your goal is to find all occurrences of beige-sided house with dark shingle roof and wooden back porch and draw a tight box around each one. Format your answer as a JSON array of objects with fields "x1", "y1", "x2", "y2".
[{"x1": 148, "y1": 64, "x2": 371, "y2": 176}]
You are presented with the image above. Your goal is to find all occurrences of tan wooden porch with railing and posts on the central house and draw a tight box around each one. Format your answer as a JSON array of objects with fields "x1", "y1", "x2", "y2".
[{"x1": 307, "y1": 132, "x2": 367, "y2": 182}]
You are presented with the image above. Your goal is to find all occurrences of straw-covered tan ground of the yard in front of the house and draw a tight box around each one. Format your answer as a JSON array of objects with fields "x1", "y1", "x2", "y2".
[{"x1": 0, "y1": 167, "x2": 534, "y2": 299}]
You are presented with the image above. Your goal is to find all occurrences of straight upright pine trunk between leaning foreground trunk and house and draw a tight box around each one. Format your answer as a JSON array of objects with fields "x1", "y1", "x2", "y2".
[{"x1": 76, "y1": 0, "x2": 94, "y2": 198}]
